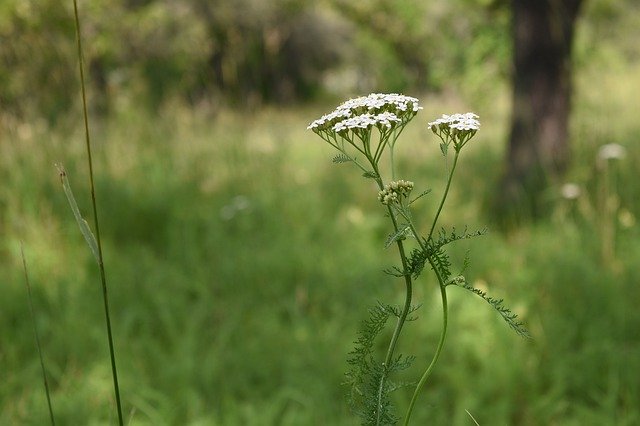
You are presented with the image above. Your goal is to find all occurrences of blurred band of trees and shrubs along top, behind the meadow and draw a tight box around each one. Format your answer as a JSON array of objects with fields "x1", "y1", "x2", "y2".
[{"x1": 0, "y1": 0, "x2": 638, "y2": 122}]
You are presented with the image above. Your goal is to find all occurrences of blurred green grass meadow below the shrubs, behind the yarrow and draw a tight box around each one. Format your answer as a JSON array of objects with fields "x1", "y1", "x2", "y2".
[{"x1": 0, "y1": 58, "x2": 640, "y2": 426}]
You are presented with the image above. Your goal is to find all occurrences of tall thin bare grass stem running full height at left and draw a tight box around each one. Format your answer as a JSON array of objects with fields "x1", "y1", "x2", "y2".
[{"x1": 73, "y1": 0, "x2": 124, "y2": 426}]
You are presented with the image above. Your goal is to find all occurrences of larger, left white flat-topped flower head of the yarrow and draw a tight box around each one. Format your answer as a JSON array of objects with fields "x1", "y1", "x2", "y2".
[{"x1": 307, "y1": 93, "x2": 422, "y2": 133}]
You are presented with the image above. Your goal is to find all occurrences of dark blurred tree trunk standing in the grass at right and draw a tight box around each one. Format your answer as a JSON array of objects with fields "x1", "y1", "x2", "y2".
[{"x1": 497, "y1": 0, "x2": 583, "y2": 222}]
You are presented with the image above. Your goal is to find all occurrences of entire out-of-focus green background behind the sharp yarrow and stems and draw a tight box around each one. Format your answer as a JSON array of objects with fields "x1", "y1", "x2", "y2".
[{"x1": 0, "y1": 0, "x2": 640, "y2": 425}]
